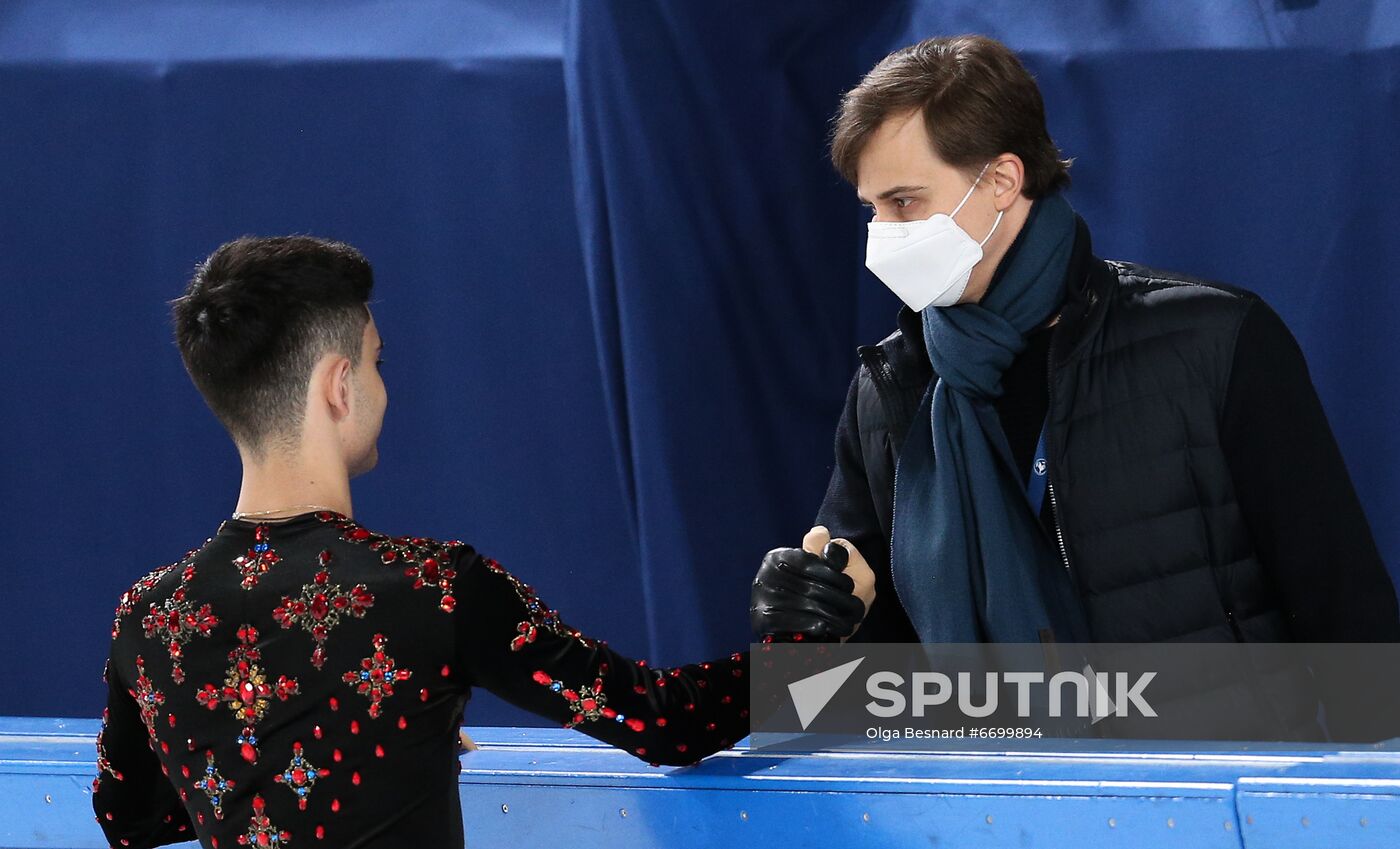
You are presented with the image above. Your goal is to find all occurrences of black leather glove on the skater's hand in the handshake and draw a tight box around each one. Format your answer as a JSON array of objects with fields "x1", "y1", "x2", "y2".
[{"x1": 749, "y1": 542, "x2": 865, "y2": 642}]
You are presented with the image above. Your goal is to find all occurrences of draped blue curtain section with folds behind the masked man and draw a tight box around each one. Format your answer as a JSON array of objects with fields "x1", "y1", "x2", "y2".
[{"x1": 564, "y1": 0, "x2": 1400, "y2": 666}]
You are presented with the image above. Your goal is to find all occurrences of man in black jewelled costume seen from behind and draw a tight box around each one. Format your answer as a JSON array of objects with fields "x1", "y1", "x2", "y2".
[{"x1": 92, "y1": 237, "x2": 874, "y2": 848}]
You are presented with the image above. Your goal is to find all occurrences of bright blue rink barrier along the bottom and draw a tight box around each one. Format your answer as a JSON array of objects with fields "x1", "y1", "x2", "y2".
[{"x1": 0, "y1": 717, "x2": 1400, "y2": 849}]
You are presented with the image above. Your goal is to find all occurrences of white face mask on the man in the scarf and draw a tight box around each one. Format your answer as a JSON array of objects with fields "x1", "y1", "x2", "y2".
[{"x1": 865, "y1": 163, "x2": 1002, "y2": 312}]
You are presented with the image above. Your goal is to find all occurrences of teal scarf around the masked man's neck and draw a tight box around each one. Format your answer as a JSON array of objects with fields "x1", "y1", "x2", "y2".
[{"x1": 890, "y1": 195, "x2": 1089, "y2": 643}]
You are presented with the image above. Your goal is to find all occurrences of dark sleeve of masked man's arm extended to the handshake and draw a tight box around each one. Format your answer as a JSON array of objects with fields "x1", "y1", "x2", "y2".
[{"x1": 816, "y1": 371, "x2": 918, "y2": 643}]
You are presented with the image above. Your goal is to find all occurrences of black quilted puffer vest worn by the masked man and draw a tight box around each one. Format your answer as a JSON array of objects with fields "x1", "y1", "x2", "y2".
[{"x1": 857, "y1": 221, "x2": 1320, "y2": 740}]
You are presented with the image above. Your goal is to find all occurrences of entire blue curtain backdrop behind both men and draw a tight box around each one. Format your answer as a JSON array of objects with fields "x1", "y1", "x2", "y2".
[{"x1": 0, "y1": 0, "x2": 1400, "y2": 724}]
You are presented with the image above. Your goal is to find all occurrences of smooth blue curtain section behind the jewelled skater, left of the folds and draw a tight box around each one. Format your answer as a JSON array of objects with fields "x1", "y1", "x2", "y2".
[{"x1": 0, "y1": 0, "x2": 641, "y2": 723}]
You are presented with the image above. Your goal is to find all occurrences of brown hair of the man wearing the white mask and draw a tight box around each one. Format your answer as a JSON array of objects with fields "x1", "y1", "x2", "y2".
[{"x1": 832, "y1": 35, "x2": 1070, "y2": 199}]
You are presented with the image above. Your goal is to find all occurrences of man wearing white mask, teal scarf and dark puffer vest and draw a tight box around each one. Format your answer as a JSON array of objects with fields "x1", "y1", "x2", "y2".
[{"x1": 784, "y1": 36, "x2": 1400, "y2": 740}]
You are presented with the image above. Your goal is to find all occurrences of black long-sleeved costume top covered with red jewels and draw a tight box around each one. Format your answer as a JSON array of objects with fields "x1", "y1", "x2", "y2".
[{"x1": 92, "y1": 511, "x2": 749, "y2": 849}]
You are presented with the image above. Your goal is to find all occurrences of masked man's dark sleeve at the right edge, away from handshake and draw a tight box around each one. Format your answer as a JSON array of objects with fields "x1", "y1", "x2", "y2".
[{"x1": 1221, "y1": 303, "x2": 1400, "y2": 738}]
